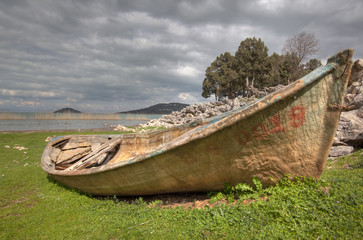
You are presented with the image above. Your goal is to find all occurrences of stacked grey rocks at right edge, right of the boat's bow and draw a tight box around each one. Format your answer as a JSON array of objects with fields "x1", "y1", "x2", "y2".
[{"x1": 329, "y1": 59, "x2": 363, "y2": 157}]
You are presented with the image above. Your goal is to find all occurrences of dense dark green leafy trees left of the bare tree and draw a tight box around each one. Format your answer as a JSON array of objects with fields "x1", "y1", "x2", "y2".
[{"x1": 202, "y1": 38, "x2": 271, "y2": 99}]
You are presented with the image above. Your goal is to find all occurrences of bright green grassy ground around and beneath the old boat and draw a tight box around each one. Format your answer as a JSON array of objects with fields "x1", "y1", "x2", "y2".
[{"x1": 0, "y1": 133, "x2": 363, "y2": 239}]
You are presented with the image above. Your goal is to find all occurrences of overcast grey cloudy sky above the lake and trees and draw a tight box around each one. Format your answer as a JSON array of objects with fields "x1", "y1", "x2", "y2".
[{"x1": 0, "y1": 0, "x2": 363, "y2": 113}]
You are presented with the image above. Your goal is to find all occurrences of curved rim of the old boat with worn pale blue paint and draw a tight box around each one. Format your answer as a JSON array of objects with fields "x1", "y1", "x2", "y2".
[{"x1": 42, "y1": 50, "x2": 349, "y2": 176}]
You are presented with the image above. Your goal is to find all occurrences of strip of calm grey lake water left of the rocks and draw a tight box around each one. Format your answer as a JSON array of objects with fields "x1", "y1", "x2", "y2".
[{"x1": 0, "y1": 113, "x2": 161, "y2": 131}]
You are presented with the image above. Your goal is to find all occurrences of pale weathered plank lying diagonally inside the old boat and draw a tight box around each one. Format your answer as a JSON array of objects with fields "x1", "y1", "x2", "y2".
[{"x1": 65, "y1": 138, "x2": 121, "y2": 171}]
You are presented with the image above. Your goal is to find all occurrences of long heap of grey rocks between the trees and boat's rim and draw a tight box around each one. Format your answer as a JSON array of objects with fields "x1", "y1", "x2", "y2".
[{"x1": 141, "y1": 96, "x2": 257, "y2": 128}]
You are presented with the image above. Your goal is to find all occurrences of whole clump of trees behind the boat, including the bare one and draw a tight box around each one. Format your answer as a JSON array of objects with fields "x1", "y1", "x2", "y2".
[{"x1": 202, "y1": 32, "x2": 322, "y2": 100}]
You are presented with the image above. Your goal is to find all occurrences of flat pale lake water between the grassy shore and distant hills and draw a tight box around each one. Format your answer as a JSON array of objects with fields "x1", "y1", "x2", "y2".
[{"x1": 0, "y1": 113, "x2": 161, "y2": 131}]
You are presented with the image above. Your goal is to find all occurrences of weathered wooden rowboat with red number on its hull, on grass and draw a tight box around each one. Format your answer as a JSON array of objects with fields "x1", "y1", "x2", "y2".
[{"x1": 41, "y1": 49, "x2": 353, "y2": 196}]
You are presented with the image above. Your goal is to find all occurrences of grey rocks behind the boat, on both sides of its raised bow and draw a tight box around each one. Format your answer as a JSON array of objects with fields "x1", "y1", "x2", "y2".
[{"x1": 115, "y1": 59, "x2": 363, "y2": 157}]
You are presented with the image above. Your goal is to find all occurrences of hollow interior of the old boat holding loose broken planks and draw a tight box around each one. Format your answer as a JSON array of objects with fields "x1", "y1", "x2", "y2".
[{"x1": 47, "y1": 126, "x2": 194, "y2": 171}]
